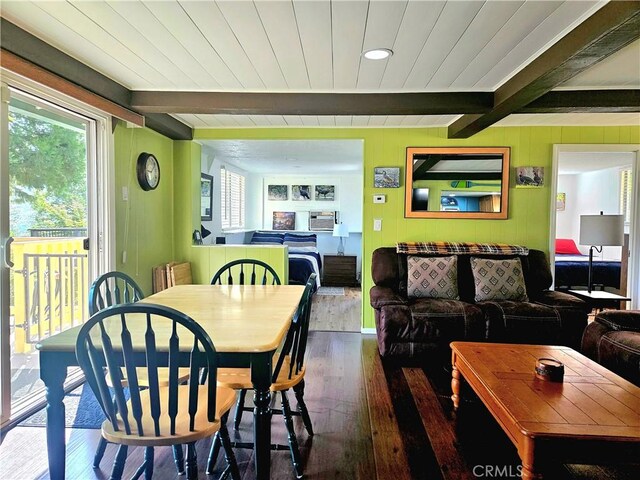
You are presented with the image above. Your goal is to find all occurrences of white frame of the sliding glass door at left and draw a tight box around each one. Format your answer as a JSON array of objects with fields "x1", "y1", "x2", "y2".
[{"x1": 0, "y1": 69, "x2": 116, "y2": 425}]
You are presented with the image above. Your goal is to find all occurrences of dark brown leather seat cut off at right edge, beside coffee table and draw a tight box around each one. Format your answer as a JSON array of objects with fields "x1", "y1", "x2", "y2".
[{"x1": 582, "y1": 310, "x2": 640, "y2": 387}]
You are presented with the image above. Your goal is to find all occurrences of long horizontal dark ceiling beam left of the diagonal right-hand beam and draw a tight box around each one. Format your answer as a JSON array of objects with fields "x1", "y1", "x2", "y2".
[{"x1": 131, "y1": 90, "x2": 493, "y2": 115}]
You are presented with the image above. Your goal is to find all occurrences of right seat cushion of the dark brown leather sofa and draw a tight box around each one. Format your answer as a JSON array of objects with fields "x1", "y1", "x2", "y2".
[{"x1": 477, "y1": 301, "x2": 562, "y2": 345}]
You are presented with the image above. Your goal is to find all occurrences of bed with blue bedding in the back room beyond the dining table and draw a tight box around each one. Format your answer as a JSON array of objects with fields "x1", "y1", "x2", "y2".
[{"x1": 251, "y1": 232, "x2": 322, "y2": 289}]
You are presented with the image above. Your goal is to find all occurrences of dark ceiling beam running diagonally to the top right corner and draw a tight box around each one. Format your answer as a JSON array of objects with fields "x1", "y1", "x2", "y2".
[{"x1": 448, "y1": 1, "x2": 640, "y2": 138}]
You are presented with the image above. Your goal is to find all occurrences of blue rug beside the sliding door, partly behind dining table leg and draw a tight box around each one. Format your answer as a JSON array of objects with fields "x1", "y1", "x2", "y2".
[{"x1": 18, "y1": 385, "x2": 115, "y2": 429}]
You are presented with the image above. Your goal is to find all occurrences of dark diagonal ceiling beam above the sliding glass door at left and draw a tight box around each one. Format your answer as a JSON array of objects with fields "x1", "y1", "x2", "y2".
[{"x1": 0, "y1": 18, "x2": 193, "y2": 140}]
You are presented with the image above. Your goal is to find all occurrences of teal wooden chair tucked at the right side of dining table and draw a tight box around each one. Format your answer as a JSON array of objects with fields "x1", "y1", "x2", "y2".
[{"x1": 207, "y1": 273, "x2": 316, "y2": 478}]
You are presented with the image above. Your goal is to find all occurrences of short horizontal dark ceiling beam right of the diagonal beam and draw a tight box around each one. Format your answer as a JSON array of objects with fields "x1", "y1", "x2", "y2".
[{"x1": 516, "y1": 90, "x2": 640, "y2": 113}]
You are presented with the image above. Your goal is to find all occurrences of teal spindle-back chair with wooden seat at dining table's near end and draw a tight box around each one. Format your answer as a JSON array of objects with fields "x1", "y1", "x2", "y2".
[{"x1": 76, "y1": 303, "x2": 240, "y2": 480}]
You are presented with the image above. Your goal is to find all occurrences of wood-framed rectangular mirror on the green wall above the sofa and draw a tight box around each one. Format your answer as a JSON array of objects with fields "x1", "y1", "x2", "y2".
[{"x1": 404, "y1": 147, "x2": 510, "y2": 220}]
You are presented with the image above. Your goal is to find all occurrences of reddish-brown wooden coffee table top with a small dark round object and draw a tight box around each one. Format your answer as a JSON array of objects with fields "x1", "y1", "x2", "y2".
[{"x1": 451, "y1": 342, "x2": 640, "y2": 442}]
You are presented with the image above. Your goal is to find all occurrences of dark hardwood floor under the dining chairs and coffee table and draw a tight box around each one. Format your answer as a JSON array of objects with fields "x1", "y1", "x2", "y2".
[{"x1": 0, "y1": 332, "x2": 640, "y2": 480}]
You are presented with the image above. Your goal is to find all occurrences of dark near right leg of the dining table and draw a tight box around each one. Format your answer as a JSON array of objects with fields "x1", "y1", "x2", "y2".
[{"x1": 251, "y1": 352, "x2": 273, "y2": 480}]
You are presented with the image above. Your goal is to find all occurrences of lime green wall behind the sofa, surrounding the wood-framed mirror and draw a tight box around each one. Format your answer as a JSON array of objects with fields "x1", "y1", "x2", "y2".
[{"x1": 190, "y1": 126, "x2": 640, "y2": 328}]
